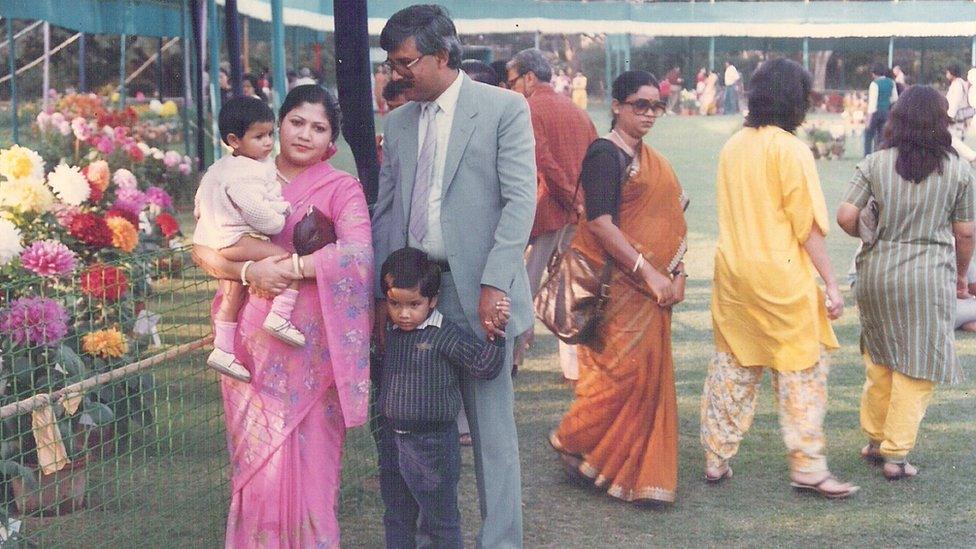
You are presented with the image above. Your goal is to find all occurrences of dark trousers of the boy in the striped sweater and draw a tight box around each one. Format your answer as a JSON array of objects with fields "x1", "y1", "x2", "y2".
[{"x1": 380, "y1": 420, "x2": 463, "y2": 549}]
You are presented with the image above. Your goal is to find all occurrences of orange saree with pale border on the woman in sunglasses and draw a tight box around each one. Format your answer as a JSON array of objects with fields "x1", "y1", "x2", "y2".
[{"x1": 550, "y1": 145, "x2": 687, "y2": 502}]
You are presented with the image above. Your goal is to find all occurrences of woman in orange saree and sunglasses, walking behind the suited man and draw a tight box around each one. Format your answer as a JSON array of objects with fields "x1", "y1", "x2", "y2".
[{"x1": 550, "y1": 71, "x2": 687, "y2": 502}]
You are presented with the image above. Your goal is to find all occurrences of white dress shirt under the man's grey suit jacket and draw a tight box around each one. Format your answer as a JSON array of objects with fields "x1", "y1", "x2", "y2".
[{"x1": 409, "y1": 71, "x2": 464, "y2": 261}]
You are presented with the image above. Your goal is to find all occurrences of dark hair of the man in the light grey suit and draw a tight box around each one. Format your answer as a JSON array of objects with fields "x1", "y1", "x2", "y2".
[{"x1": 380, "y1": 4, "x2": 461, "y2": 69}]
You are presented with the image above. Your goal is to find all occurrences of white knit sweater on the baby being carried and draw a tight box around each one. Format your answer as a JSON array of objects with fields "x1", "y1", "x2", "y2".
[{"x1": 193, "y1": 156, "x2": 288, "y2": 250}]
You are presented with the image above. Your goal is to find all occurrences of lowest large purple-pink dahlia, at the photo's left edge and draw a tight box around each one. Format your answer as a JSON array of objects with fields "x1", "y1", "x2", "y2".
[{"x1": 0, "y1": 297, "x2": 68, "y2": 345}]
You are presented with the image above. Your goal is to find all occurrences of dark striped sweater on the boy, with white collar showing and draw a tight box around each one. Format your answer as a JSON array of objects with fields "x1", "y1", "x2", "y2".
[{"x1": 379, "y1": 310, "x2": 505, "y2": 422}]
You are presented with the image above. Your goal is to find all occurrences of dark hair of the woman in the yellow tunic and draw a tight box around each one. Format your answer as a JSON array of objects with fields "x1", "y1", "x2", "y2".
[{"x1": 745, "y1": 59, "x2": 813, "y2": 133}]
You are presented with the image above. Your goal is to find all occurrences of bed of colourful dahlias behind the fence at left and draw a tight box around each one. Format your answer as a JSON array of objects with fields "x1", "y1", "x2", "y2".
[{"x1": 0, "y1": 140, "x2": 191, "y2": 518}]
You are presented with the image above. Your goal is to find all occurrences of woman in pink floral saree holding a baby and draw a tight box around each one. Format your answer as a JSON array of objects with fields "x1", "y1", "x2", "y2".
[{"x1": 194, "y1": 86, "x2": 372, "y2": 548}]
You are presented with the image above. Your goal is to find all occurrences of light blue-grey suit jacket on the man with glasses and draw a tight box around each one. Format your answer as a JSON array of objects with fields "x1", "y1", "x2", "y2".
[{"x1": 372, "y1": 75, "x2": 536, "y2": 335}]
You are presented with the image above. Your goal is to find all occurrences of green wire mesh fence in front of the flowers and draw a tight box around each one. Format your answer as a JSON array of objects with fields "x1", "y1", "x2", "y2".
[{"x1": 0, "y1": 249, "x2": 376, "y2": 549}]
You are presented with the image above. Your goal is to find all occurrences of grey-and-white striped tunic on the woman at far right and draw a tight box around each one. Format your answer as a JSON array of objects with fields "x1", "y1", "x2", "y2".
[{"x1": 844, "y1": 149, "x2": 974, "y2": 383}]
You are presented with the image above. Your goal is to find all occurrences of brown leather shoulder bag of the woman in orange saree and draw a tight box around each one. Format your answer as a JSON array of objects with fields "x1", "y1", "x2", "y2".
[{"x1": 533, "y1": 143, "x2": 628, "y2": 348}]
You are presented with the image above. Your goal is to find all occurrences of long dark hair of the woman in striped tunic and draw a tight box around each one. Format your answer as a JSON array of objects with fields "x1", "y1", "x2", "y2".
[{"x1": 881, "y1": 86, "x2": 956, "y2": 183}]
